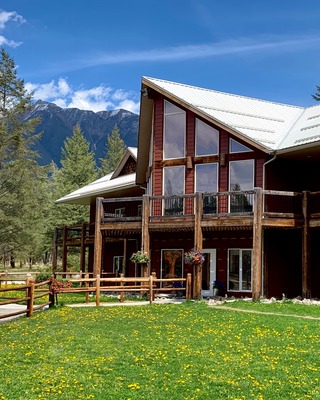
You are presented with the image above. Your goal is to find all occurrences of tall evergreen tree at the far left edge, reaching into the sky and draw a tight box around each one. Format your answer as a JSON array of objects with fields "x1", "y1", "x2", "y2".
[{"x1": 0, "y1": 48, "x2": 43, "y2": 265}]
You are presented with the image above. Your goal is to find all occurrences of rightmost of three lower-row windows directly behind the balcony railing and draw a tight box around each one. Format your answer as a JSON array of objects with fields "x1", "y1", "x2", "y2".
[{"x1": 229, "y1": 160, "x2": 254, "y2": 213}]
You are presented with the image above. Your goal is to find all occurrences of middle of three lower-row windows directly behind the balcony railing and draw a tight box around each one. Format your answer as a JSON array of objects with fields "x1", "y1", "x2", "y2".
[{"x1": 195, "y1": 163, "x2": 218, "y2": 214}]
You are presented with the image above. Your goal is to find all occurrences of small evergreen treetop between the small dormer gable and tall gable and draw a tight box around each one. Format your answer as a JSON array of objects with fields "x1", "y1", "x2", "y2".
[{"x1": 99, "y1": 125, "x2": 126, "y2": 176}]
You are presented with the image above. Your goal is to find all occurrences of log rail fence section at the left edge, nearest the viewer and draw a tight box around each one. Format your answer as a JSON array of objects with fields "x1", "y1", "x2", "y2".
[{"x1": 0, "y1": 278, "x2": 54, "y2": 319}]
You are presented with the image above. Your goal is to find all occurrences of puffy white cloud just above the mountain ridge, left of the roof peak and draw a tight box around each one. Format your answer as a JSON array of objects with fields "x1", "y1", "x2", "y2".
[{"x1": 25, "y1": 78, "x2": 140, "y2": 113}]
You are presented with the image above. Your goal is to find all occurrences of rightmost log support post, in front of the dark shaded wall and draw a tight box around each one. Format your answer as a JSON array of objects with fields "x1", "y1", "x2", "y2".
[{"x1": 302, "y1": 191, "x2": 311, "y2": 299}]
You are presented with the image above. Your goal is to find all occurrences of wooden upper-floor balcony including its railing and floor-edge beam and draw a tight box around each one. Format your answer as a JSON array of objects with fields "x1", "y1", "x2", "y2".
[{"x1": 97, "y1": 189, "x2": 314, "y2": 233}]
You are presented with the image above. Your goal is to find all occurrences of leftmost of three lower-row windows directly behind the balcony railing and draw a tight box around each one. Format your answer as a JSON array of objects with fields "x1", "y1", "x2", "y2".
[{"x1": 163, "y1": 166, "x2": 185, "y2": 215}]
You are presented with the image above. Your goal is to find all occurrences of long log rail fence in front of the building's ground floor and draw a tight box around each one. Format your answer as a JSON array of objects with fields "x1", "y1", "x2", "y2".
[{"x1": 53, "y1": 274, "x2": 191, "y2": 306}]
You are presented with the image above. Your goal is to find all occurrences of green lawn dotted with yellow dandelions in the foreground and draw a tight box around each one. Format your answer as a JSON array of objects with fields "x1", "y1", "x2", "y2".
[{"x1": 0, "y1": 302, "x2": 320, "y2": 400}]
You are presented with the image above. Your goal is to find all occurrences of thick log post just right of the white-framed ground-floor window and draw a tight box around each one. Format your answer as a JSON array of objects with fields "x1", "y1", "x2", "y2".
[{"x1": 252, "y1": 188, "x2": 263, "y2": 300}]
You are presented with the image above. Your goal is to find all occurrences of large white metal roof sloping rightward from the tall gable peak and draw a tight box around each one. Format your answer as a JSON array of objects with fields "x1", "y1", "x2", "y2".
[{"x1": 143, "y1": 77, "x2": 320, "y2": 150}]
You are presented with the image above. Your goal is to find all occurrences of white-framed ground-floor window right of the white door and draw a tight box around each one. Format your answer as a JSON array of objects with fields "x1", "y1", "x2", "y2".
[{"x1": 228, "y1": 249, "x2": 252, "y2": 292}]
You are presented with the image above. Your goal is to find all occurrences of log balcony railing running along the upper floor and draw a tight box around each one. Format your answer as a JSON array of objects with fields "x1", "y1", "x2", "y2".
[{"x1": 97, "y1": 190, "x2": 310, "y2": 223}]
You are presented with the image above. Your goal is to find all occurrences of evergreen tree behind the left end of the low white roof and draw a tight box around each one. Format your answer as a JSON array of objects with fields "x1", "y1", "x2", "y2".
[{"x1": 53, "y1": 125, "x2": 97, "y2": 226}]
